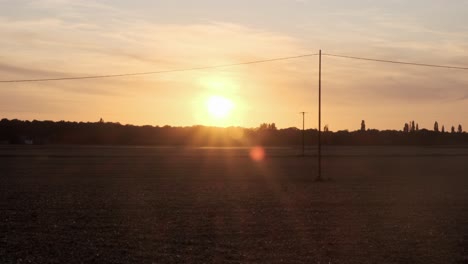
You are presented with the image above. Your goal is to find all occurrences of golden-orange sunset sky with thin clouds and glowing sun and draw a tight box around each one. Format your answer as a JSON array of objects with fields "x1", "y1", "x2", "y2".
[{"x1": 0, "y1": 0, "x2": 468, "y2": 131}]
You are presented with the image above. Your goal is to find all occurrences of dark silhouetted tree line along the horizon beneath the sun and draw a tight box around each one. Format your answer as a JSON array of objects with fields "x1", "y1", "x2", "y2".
[{"x1": 0, "y1": 119, "x2": 468, "y2": 146}]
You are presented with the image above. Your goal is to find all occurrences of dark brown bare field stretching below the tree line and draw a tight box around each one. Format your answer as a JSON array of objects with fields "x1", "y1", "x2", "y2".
[{"x1": 0, "y1": 146, "x2": 468, "y2": 264}]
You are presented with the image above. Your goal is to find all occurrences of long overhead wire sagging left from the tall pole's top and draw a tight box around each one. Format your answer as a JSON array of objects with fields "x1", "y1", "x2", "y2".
[{"x1": 0, "y1": 54, "x2": 318, "y2": 83}]
